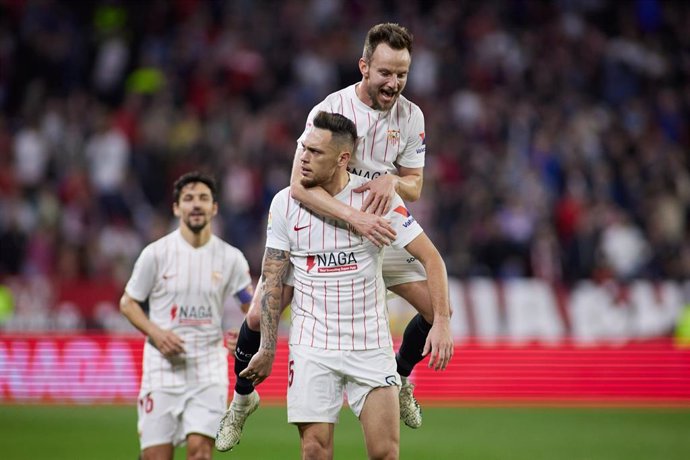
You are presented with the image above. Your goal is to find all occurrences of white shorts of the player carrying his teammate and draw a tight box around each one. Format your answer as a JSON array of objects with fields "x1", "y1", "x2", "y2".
[{"x1": 287, "y1": 345, "x2": 400, "y2": 423}]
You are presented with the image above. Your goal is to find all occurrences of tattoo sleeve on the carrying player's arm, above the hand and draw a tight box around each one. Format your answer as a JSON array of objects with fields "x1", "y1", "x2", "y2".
[{"x1": 261, "y1": 248, "x2": 290, "y2": 351}]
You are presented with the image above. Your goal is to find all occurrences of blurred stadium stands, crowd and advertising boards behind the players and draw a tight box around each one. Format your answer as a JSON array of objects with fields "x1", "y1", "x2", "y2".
[{"x1": 0, "y1": 0, "x2": 690, "y2": 458}]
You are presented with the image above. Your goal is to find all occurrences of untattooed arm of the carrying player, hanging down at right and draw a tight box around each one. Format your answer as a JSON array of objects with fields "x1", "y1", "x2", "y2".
[{"x1": 405, "y1": 233, "x2": 453, "y2": 370}]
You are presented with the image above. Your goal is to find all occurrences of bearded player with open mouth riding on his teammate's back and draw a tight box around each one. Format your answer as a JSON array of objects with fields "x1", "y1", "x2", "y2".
[{"x1": 216, "y1": 23, "x2": 453, "y2": 451}]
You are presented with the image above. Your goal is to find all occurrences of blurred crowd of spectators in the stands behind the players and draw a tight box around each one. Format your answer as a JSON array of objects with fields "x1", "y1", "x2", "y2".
[{"x1": 0, "y1": 0, "x2": 690, "y2": 329}]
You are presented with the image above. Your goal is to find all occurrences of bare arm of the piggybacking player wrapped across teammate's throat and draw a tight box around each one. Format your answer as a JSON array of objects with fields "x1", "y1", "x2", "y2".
[{"x1": 290, "y1": 146, "x2": 395, "y2": 247}]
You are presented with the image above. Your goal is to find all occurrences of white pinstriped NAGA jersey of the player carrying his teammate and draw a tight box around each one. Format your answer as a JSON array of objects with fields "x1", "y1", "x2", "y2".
[{"x1": 266, "y1": 174, "x2": 422, "y2": 350}]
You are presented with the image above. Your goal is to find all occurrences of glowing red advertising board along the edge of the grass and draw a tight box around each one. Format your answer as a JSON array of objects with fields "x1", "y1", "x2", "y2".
[{"x1": 0, "y1": 335, "x2": 690, "y2": 405}]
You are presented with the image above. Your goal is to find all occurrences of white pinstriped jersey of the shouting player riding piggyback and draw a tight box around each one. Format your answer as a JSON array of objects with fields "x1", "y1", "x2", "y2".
[{"x1": 297, "y1": 85, "x2": 426, "y2": 179}]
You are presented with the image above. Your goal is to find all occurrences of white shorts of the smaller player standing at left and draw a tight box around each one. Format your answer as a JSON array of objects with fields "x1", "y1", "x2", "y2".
[{"x1": 137, "y1": 384, "x2": 228, "y2": 450}]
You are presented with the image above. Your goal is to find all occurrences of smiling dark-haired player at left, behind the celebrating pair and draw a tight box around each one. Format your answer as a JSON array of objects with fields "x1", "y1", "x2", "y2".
[{"x1": 120, "y1": 172, "x2": 253, "y2": 460}]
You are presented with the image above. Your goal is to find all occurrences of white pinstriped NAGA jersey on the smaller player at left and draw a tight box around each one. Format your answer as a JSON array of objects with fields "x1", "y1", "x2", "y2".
[{"x1": 125, "y1": 229, "x2": 252, "y2": 390}]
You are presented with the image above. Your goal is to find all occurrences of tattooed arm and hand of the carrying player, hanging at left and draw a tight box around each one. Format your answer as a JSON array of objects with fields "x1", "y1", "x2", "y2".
[{"x1": 240, "y1": 248, "x2": 290, "y2": 385}]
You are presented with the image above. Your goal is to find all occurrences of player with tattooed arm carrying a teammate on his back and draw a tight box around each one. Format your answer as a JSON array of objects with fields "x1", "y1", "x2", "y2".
[{"x1": 241, "y1": 112, "x2": 452, "y2": 459}]
